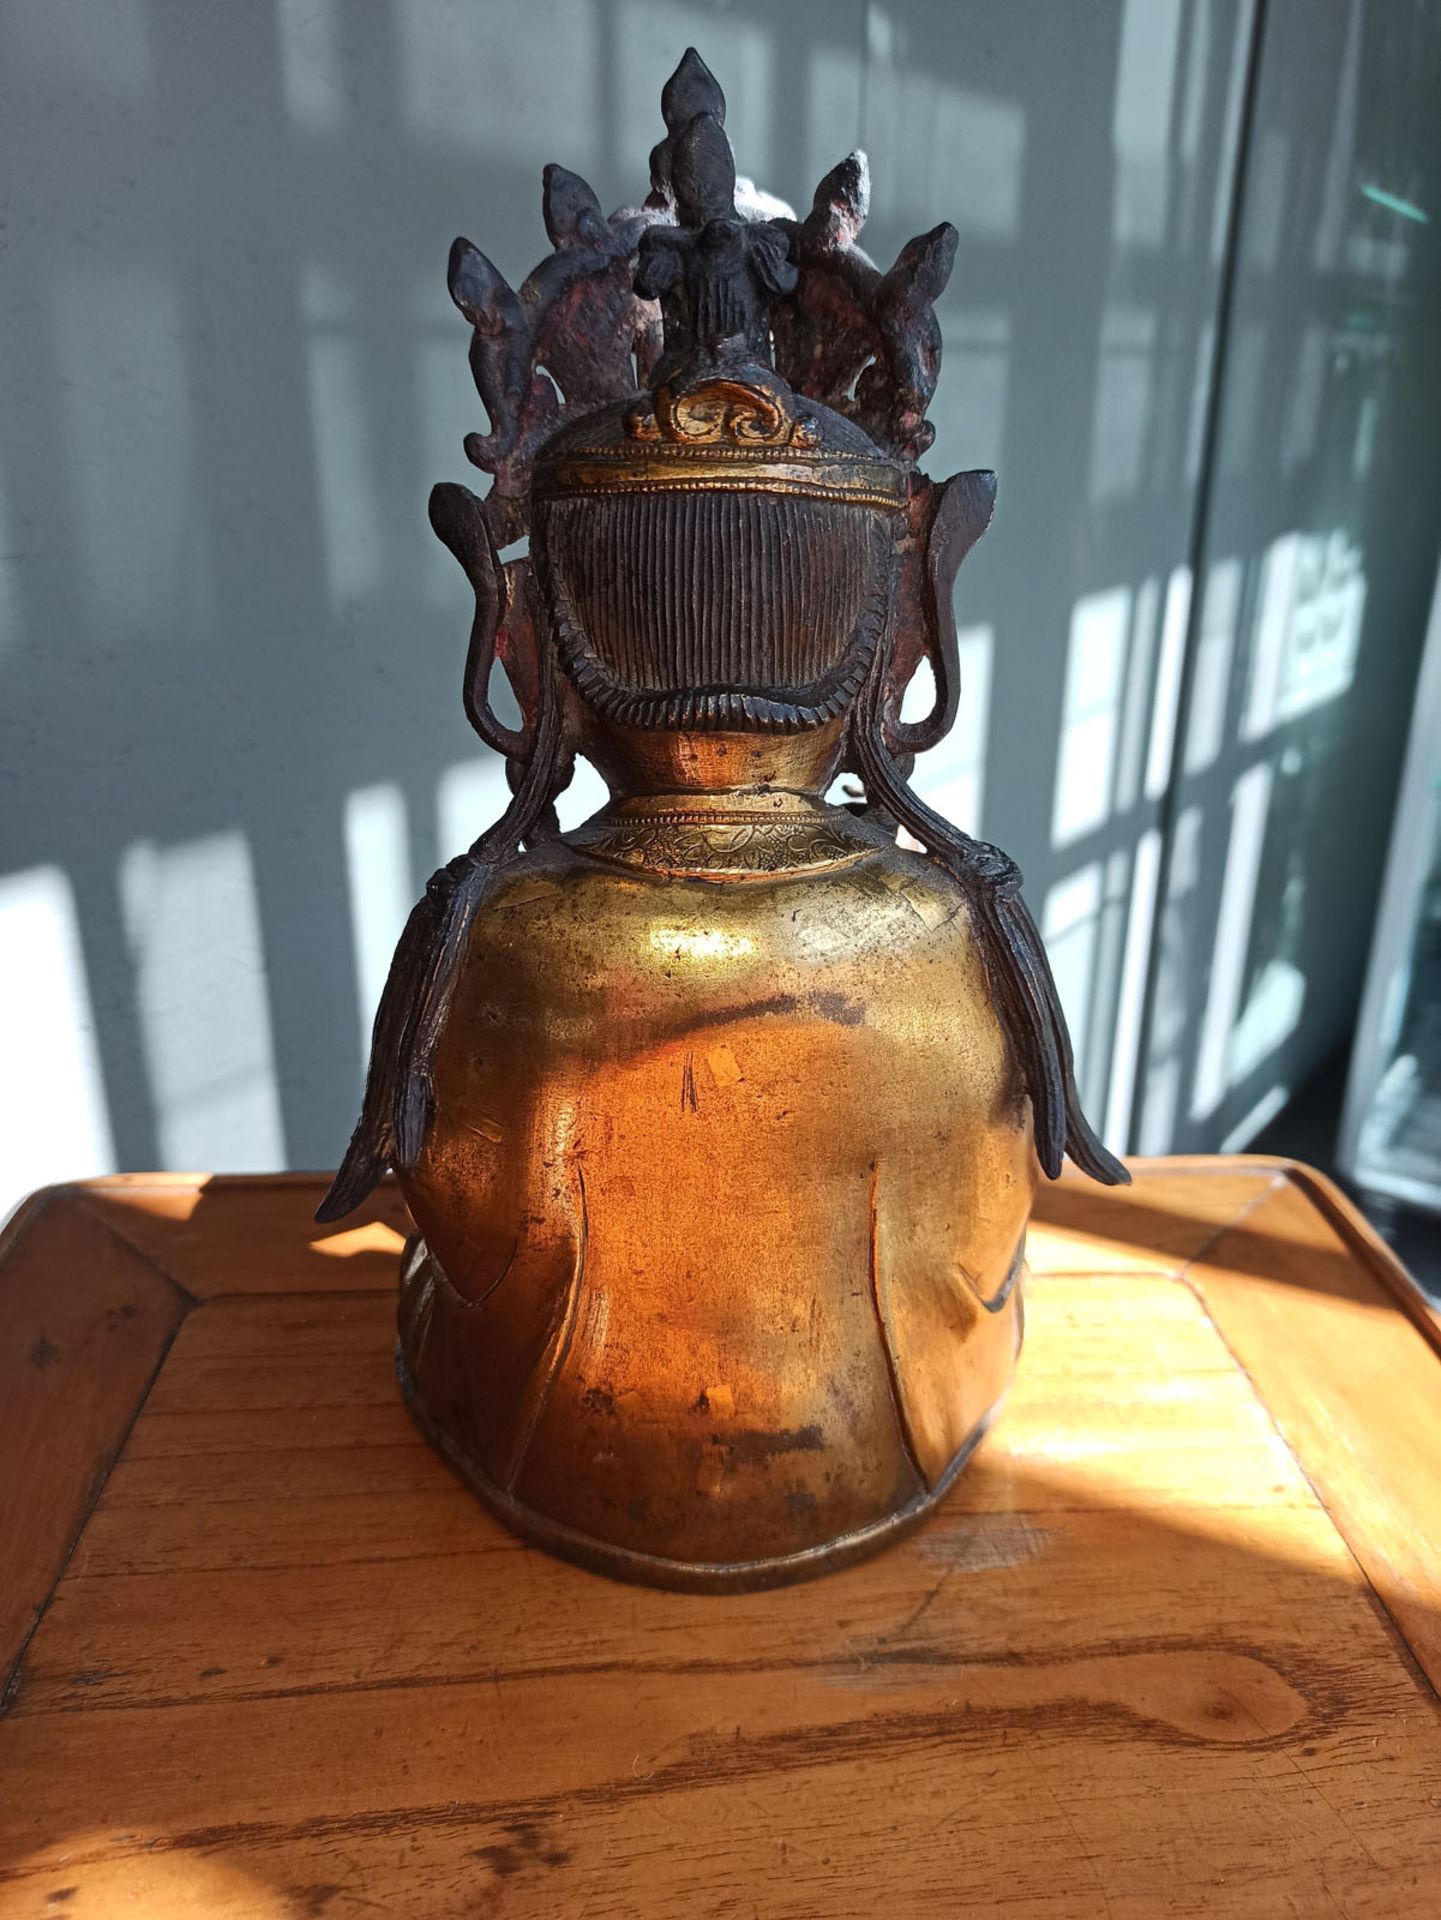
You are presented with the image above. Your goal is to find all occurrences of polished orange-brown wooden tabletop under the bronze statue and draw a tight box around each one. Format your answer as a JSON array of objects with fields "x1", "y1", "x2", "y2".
[{"x1": 0, "y1": 1160, "x2": 1441, "y2": 1920}]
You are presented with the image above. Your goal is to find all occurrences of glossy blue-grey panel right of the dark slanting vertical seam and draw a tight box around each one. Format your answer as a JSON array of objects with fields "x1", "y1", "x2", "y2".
[{"x1": 1134, "y1": 0, "x2": 1441, "y2": 1150}]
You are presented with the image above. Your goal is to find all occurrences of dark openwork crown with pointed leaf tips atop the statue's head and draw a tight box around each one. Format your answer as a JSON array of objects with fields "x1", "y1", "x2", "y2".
[{"x1": 449, "y1": 48, "x2": 956, "y2": 526}]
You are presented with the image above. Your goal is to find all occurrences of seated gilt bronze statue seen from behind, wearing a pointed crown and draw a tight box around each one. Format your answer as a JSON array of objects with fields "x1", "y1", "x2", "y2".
[{"x1": 320, "y1": 54, "x2": 1126, "y2": 1588}]
